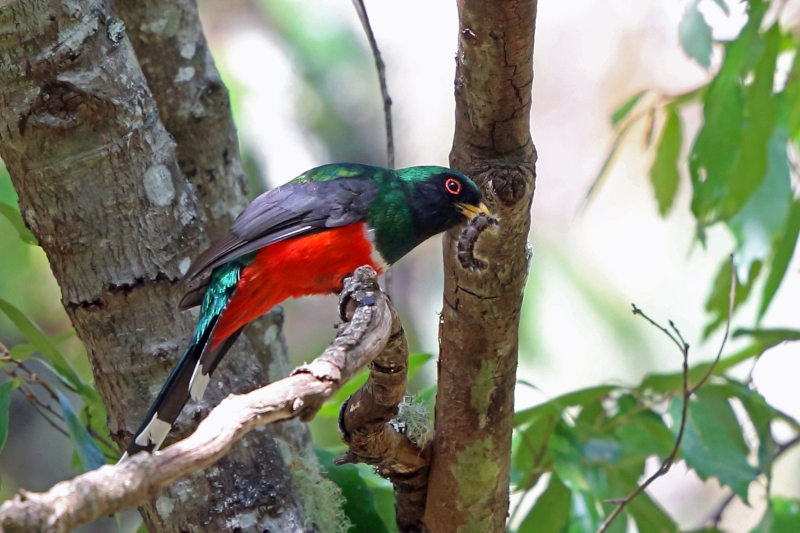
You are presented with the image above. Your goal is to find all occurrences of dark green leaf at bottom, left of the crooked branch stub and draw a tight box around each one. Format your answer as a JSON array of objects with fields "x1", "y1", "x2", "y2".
[{"x1": 315, "y1": 447, "x2": 389, "y2": 533}]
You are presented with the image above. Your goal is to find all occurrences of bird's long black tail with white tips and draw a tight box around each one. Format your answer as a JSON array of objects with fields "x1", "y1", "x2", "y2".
[{"x1": 120, "y1": 313, "x2": 242, "y2": 461}]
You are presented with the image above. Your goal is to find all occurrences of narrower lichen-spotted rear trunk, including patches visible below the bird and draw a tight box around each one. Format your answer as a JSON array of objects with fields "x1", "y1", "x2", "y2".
[{"x1": 110, "y1": 0, "x2": 319, "y2": 528}]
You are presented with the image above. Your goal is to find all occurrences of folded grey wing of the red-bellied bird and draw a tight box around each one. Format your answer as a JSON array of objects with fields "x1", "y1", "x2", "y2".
[{"x1": 180, "y1": 178, "x2": 378, "y2": 309}]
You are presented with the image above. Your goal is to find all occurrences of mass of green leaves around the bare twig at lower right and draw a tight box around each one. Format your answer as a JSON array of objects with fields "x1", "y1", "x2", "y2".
[{"x1": 512, "y1": 367, "x2": 784, "y2": 533}]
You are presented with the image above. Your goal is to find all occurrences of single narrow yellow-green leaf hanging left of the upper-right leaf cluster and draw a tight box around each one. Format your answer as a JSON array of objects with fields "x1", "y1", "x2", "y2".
[{"x1": 650, "y1": 108, "x2": 682, "y2": 216}]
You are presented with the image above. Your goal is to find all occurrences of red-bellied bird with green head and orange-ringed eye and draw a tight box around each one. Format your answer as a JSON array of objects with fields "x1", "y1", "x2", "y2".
[{"x1": 121, "y1": 163, "x2": 489, "y2": 461}]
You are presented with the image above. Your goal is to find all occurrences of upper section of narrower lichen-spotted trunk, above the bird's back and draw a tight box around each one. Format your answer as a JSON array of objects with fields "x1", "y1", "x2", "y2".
[{"x1": 115, "y1": 0, "x2": 247, "y2": 240}]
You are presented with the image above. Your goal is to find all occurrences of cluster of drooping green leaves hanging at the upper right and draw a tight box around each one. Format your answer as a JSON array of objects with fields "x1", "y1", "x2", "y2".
[{"x1": 589, "y1": 0, "x2": 800, "y2": 337}]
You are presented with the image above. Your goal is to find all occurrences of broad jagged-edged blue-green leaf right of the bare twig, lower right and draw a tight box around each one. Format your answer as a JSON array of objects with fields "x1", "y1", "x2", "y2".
[{"x1": 669, "y1": 389, "x2": 757, "y2": 502}]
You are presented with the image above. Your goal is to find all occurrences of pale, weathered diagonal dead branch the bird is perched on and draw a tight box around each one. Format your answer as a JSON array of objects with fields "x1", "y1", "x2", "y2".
[{"x1": 0, "y1": 267, "x2": 393, "y2": 533}]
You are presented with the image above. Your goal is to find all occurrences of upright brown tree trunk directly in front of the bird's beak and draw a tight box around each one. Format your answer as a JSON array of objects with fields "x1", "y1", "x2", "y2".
[{"x1": 425, "y1": 0, "x2": 536, "y2": 533}]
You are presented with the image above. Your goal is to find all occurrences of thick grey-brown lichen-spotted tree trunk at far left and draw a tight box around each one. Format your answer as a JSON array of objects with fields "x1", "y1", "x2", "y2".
[{"x1": 0, "y1": 0, "x2": 313, "y2": 532}]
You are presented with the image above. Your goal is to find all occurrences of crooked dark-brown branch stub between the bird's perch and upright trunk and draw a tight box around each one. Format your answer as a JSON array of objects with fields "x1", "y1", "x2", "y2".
[{"x1": 334, "y1": 304, "x2": 430, "y2": 533}]
